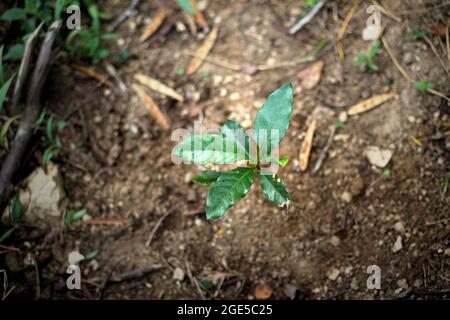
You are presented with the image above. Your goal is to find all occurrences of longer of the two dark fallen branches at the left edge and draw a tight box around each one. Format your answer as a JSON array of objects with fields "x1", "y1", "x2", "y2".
[{"x1": 0, "y1": 21, "x2": 61, "y2": 216}]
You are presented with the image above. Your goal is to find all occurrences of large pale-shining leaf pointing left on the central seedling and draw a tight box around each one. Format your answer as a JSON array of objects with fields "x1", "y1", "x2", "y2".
[{"x1": 175, "y1": 135, "x2": 245, "y2": 165}]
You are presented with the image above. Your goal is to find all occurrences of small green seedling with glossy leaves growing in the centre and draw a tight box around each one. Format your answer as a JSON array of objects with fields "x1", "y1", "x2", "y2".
[{"x1": 174, "y1": 83, "x2": 293, "y2": 219}]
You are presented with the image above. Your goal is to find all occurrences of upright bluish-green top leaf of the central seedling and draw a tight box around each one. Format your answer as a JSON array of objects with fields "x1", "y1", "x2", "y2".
[{"x1": 254, "y1": 83, "x2": 293, "y2": 155}]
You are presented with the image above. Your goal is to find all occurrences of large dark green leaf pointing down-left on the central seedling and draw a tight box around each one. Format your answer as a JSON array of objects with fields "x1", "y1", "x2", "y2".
[{"x1": 206, "y1": 168, "x2": 254, "y2": 219}]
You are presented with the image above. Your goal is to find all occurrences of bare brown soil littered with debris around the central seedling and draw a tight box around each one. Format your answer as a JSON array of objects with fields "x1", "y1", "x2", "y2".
[{"x1": 0, "y1": 1, "x2": 450, "y2": 299}]
